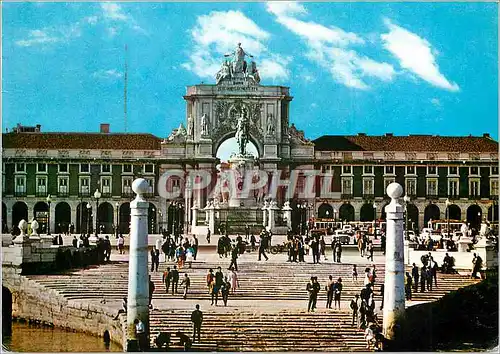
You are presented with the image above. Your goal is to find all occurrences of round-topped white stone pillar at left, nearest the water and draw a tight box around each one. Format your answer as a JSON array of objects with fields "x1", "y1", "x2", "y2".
[{"x1": 126, "y1": 178, "x2": 149, "y2": 351}]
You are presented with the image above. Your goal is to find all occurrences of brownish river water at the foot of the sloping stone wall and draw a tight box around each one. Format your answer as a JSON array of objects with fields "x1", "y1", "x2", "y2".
[{"x1": 3, "y1": 322, "x2": 123, "y2": 353}]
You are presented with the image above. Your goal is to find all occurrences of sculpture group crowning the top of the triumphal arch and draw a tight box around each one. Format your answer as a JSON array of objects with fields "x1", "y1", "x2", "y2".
[{"x1": 215, "y1": 43, "x2": 260, "y2": 84}]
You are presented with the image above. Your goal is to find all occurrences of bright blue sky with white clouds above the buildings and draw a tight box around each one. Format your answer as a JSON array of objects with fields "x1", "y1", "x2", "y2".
[{"x1": 2, "y1": 2, "x2": 498, "y2": 143}]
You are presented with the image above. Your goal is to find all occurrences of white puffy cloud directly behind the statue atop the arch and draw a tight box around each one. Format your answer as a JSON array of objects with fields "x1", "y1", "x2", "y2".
[{"x1": 181, "y1": 11, "x2": 290, "y2": 80}]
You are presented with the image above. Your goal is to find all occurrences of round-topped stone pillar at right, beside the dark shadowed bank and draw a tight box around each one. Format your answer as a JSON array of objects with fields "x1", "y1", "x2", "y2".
[{"x1": 383, "y1": 183, "x2": 405, "y2": 341}]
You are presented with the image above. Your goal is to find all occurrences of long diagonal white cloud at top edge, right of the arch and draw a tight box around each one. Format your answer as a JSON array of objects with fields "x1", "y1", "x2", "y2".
[{"x1": 266, "y1": 2, "x2": 395, "y2": 90}]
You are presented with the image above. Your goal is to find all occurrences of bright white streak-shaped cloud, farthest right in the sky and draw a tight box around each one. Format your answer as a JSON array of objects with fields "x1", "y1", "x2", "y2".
[{"x1": 380, "y1": 19, "x2": 460, "y2": 91}]
